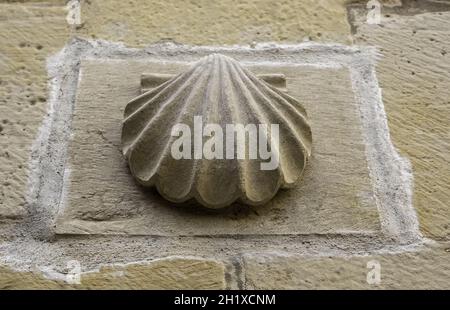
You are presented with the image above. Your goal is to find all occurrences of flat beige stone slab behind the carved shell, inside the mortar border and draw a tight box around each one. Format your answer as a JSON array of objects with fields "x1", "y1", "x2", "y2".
[{"x1": 57, "y1": 60, "x2": 380, "y2": 235}]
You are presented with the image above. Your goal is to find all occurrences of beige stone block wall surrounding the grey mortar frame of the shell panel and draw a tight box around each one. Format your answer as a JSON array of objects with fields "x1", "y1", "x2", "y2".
[{"x1": 0, "y1": 0, "x2": 450, "y2": 289}]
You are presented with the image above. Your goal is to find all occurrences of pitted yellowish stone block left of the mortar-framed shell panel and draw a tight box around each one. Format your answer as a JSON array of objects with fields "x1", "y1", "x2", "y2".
[{"x1": 0, "y1": 4, "x2": 68, "y2": 218}]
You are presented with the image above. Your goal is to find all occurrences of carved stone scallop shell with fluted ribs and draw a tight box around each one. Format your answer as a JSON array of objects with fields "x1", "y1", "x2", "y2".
[{"x1": 122, "y1": 54, "x2": 312, "y2": 209}]
